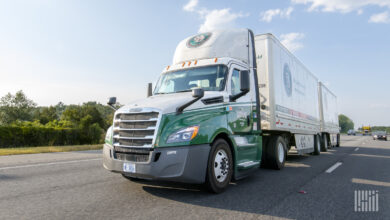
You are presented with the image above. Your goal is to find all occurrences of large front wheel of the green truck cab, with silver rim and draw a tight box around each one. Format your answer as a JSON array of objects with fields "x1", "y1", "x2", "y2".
[{"x1": 206, "y1": 139, "x2": 233, "y2": 193}]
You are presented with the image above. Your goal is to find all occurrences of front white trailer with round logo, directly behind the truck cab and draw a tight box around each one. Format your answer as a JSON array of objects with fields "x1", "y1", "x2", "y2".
[{"x1": 255, "y1": 34, "x2": 320, "y2": 154}]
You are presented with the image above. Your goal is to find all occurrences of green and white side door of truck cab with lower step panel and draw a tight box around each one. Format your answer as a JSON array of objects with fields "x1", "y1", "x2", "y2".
[{"x1": 226, "y1": 64, "x2": 260, "y2": 169}]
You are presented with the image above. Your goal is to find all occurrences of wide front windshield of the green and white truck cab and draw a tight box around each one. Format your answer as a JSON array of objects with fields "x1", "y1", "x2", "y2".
[{"x1": 154, "y1": 65, "x2": 227, "y2": 94}]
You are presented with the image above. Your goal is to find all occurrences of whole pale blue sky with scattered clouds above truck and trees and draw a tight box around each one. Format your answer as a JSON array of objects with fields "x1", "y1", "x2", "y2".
[{"x1": 0, "y1": 0, "x2": 390, "y2": 128}]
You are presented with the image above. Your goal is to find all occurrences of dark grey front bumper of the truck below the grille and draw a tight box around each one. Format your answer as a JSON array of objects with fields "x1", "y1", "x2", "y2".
[{"x1": 103, "y1": 144, "x2": 210, "y2": 183}]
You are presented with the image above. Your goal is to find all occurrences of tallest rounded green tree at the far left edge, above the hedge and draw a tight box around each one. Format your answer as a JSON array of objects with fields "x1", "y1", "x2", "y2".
[{"x1": 0, "y1": 90, "x2": 36, "y2": 124}]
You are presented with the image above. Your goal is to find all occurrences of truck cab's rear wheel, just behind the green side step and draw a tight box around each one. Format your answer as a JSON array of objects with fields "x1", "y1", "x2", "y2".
[{"x1": 266, "y1": 135, "x2": 287, "y2": 170}]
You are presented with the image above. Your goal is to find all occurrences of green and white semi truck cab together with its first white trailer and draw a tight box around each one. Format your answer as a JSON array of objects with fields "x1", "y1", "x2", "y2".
[{"x1": 103, "y1": 29, "x2": 340, "y2": 193}]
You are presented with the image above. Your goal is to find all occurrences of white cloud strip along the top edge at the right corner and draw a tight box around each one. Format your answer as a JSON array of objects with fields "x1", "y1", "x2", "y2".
[{"x1": 291, "y1": 0, "x2": 390, "y2": 13}]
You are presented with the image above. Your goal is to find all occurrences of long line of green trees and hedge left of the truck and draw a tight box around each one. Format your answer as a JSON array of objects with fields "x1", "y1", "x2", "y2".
[{"x1": 0, "y1": 91, "x2": 119, "y2": 148}]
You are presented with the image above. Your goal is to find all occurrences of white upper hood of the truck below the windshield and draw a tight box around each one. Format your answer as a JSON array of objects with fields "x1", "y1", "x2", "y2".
[{"x1": 118, "y1": 91, "x2": 223, "y2": 114}]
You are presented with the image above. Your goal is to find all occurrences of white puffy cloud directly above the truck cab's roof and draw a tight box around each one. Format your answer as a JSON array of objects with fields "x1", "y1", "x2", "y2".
[{"x1": 183, "y1": 0, "x2": 248, "y2": 32}]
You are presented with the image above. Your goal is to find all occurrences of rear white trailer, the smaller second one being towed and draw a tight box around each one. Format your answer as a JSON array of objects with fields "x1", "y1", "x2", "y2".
[{"x1": 318, "y1": 82, "x2": 340, "y2": 151}]
